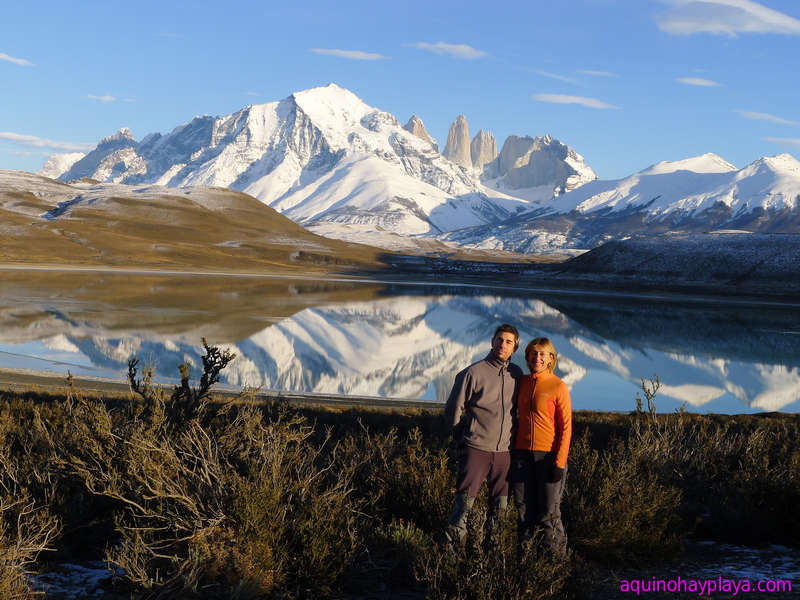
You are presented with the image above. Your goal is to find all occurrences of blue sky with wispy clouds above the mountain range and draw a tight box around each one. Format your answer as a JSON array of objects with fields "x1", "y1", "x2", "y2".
[{"x1": 0, "y1": 0, "x2": 800, "y2": 179}]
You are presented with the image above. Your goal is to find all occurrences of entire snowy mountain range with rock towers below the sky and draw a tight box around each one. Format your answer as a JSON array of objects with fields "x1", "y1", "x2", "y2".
[{"x1": 41, "y1": 84, "x2": 800, "y2": 253}]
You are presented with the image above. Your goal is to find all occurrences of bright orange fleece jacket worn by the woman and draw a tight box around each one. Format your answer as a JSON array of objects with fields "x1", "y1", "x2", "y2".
[{"x1": 514, "y1": 371, "x2": 572, "y2": 468}]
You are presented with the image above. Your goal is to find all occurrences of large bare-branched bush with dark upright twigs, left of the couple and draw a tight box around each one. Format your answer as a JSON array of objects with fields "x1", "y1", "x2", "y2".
[{"x1": 48, "y1": 346, "x2": 368, "y2": 598}]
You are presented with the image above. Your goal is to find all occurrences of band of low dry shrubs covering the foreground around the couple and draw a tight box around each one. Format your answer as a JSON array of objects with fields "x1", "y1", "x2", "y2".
[{"x1": 0, "y1": 364, "x2": 800, "y2": 600}]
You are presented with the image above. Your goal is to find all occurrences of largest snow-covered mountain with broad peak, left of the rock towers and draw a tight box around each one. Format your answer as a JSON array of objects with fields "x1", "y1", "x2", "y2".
[{"x1": 51, "y1": 84, "x2": 544, "y2": 241}]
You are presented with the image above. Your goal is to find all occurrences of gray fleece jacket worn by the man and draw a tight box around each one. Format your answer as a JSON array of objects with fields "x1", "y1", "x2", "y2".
[{"x1": 444, "y1": 352, "x2": 522, "y2": 452}]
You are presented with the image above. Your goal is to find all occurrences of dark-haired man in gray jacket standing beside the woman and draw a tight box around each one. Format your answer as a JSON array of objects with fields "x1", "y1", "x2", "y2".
[{"x1": 445, "y1": 324, "x2": 522, "y2": 547}]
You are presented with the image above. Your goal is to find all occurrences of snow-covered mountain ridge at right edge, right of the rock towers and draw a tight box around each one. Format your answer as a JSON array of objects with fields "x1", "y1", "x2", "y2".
[{"x1": 439, "y1": 154, "x2": 800, "y2": 252}]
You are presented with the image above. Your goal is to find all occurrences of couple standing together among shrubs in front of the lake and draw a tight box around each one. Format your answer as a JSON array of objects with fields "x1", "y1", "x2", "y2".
[{"x1": 445, "y1": 324, "x2": 572, "y2": 557}]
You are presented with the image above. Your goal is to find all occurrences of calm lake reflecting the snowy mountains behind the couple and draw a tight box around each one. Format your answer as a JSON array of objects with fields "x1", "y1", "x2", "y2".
[{"x1": 0, "y1": 271, "x2": 800, "y2": 413}]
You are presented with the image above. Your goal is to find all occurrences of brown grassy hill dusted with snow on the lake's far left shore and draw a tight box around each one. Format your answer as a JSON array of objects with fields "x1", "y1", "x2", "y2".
[{"x1": 0, "y1": 171, "x2": 394, "y2": 272}]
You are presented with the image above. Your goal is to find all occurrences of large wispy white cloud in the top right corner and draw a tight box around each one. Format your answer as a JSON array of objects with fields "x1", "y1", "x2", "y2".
[{"x1": 657, "y1": 0, "x2": 800, "y2": 36}]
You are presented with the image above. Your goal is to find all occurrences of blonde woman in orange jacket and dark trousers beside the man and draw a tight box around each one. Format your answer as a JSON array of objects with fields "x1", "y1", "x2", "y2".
[{"x1": 511, "y1": 338, "x2": 572, "y2": 557}]
